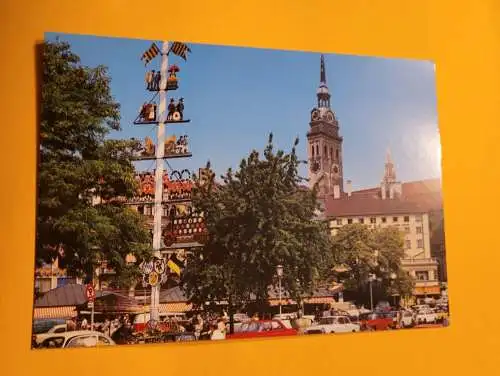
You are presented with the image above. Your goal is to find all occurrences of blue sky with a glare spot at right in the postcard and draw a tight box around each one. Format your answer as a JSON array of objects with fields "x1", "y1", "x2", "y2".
[{"x1": 46, "y1": 33, "x2": 441, "y2": 189}]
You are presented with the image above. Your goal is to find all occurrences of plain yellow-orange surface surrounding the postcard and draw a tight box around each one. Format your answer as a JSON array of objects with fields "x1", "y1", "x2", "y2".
[{"x1": 0, "y1": 0, "x2": 500, "y2": 376}]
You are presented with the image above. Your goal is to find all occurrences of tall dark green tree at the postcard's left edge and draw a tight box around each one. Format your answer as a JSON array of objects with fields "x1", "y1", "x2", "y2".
[{"x1": 36, "y1": 40, "x2": 150, "y2": 282}]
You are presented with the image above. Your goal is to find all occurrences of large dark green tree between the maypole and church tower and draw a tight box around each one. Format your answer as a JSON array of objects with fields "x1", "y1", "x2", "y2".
[{"x1": 182, "y1": 135, "x2": 331, "y2": 328}]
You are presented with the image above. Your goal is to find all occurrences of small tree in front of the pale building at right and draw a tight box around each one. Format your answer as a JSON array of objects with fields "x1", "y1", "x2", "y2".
[{"x1": 332, "y1": 223, "x2": 414, "y2": 303}]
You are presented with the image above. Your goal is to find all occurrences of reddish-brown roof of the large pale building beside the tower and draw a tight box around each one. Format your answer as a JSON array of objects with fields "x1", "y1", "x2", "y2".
[{"x1": 325, "y1": 179, "x2": 443, "y2": 217}]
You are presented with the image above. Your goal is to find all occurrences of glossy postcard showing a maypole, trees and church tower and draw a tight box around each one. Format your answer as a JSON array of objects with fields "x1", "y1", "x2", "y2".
[{"x1": 32, "y1": 33, "x2": 450, "y2": 349}]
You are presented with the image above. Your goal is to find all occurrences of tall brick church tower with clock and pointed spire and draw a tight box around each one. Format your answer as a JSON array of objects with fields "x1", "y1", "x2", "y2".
[{"x1": 307, "y1": 55, "x2": 344, "y2": 198}]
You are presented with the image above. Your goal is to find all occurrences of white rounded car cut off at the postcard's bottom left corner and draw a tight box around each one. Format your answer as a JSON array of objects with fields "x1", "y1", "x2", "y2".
[{"x1": 34, "y1": 330, "x2": 115, "y2": 348}]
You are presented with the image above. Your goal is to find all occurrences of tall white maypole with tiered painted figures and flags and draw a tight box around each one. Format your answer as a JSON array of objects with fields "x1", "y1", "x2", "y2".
[{"x1": 131, "y1": 41, "x2": 191, "y2": 325}]
